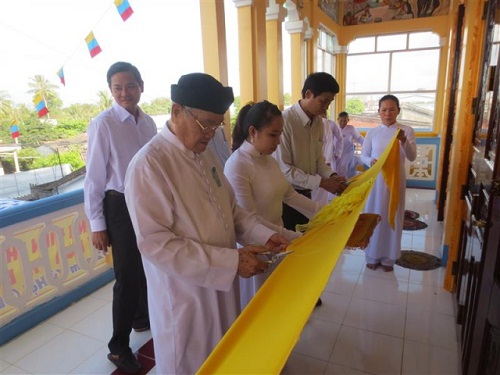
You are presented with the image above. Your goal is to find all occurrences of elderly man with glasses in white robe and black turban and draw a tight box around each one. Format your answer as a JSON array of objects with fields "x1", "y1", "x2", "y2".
[{"x1": 125, "y1": 73, "x2": 286, "y2": 374}]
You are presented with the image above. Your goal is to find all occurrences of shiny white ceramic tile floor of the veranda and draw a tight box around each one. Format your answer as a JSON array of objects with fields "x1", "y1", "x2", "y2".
[{"x1": 0, "y1": 189, "x2": 460, "y2": 375}]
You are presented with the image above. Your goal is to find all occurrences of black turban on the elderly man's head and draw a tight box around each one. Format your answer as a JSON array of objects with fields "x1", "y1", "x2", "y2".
[{"x1": 170, "y1": 73, "x2": 234, "y2": 115}]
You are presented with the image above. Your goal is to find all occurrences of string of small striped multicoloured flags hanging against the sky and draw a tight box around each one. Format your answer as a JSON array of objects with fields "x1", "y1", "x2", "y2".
[{"x1": 10, "y1": 0, "x2": 134, "y2": 140}]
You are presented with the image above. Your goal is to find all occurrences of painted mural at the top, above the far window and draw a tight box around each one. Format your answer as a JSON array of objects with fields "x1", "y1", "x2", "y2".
[{"x1": 318, "y1": 0, "x2": 450, "y2": 26}]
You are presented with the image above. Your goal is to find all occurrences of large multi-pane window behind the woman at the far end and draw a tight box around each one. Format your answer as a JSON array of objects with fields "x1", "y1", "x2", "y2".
[{"x1": 346, "y1": 32, "x2": 441, "y2": 131}]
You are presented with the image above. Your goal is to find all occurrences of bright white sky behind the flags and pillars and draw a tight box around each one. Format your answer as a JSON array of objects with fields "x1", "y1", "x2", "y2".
[{"x1": 0, "y1": 0, "x2": 239, "y2": 106}]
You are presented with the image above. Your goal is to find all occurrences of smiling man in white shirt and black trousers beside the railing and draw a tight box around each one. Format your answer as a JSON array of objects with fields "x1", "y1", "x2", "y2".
[{"x1": 84, "y1": 62, "x2": 157, "y2": 373}]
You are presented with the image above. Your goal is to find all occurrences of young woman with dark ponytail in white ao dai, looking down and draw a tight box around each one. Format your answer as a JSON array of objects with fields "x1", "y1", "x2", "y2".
[{"x1": 224, "y1": 101, "x2": 321, "y2": 308}]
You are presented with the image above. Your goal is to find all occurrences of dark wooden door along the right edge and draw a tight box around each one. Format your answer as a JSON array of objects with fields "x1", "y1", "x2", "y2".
[{"x1": 457, "y1": 0, "x2": 500, "y2": 375}]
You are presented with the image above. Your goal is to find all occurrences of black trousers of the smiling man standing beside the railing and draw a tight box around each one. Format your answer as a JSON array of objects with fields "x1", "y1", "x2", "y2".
[{"x1": 104, "y1": 191, "x2": 149, "y2": 355}]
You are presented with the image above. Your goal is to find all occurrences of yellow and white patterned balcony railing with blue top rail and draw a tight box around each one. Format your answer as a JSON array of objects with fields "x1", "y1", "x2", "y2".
[{"x1": 0, "y1": 190, "x2": 110, "y2": 327}]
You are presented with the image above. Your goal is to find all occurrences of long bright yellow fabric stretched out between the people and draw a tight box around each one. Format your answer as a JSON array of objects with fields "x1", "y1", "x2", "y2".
[{"x1": 198, "y1": 137, "x2": 397, "y2": 374}]
